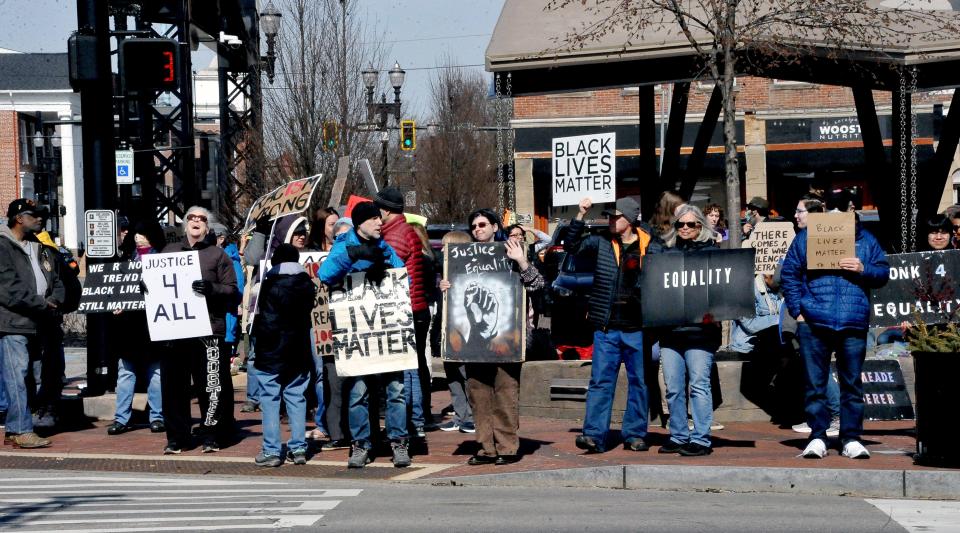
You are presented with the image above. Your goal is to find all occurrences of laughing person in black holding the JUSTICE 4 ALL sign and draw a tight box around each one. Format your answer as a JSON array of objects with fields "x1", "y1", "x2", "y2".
[{"x1": 160, "y1": 206, "x2": 240, "y2": 455}]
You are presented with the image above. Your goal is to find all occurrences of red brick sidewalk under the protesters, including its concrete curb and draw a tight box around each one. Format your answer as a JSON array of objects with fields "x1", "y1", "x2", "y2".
[{"x1": 0, "y1": 375, "x2": 960, "y2": 499}]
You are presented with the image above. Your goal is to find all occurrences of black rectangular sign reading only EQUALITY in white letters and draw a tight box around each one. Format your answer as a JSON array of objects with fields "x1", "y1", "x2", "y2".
[{"x1": 640, "y1": 248, "x2": 756, "y2": 327}]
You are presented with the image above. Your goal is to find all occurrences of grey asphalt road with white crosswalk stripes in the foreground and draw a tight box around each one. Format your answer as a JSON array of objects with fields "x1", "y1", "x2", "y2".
[{"x1": 0, "y1": 470, "x2": 960, "y2": 533}]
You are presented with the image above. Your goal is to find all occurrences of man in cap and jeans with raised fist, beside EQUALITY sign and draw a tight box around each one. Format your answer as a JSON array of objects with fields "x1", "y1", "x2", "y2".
[{"x1": 564, "y1": 197, "x2": 652, "y2": 453}]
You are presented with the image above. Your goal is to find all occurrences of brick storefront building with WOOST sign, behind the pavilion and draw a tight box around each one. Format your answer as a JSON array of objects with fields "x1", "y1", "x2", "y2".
[{"x1": 512, "y1": 77, "x2": 960, "y2": 233}]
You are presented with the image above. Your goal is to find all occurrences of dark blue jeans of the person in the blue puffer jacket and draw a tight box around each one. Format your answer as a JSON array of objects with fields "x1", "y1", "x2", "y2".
[{"x1": 797, "y1": 326, "x2": 867, "y2": 444}]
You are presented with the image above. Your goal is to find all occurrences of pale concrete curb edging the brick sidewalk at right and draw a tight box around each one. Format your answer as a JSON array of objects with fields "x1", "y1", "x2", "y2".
[{"x1": 414, "y1": 465, "x2": 960, "y2": 500}]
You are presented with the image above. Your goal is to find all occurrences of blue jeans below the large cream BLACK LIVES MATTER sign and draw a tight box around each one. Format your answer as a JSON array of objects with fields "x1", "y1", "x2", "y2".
[{"x1": 346, "y1": 372, "x2": 407, "y2": 449}]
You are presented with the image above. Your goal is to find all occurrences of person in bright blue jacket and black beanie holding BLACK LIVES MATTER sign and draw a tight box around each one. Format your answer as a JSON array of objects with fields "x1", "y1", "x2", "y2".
[{"x1": 317, "y1": 202, "x2": 411, "y2": 468}]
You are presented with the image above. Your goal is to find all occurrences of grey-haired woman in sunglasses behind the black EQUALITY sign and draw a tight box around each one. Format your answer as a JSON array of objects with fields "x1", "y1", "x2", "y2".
[{"x1": 649, "y1": 204, "x2": 720, "y2": 456}]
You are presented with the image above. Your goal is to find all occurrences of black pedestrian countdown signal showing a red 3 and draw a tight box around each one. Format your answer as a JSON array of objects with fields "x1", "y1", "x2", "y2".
[{"x1": 120, "y1": 39, "x2": 180, "y2": 93}]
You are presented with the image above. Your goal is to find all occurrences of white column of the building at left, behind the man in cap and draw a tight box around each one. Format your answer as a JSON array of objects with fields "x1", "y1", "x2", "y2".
[{"x1": 57, "y1": 112, "x2": 83, "y2": 252}]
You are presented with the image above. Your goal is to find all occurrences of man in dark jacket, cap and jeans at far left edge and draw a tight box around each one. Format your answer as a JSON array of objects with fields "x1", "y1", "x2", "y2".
[{"x1": 0, "y1": 198, "x2": 64, "y2": 448}]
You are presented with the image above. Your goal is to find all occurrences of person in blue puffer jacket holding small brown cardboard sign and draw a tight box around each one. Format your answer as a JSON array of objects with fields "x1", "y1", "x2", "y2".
[{"x1": 781, "y1": 197, "x2": 890, "y2": 459}]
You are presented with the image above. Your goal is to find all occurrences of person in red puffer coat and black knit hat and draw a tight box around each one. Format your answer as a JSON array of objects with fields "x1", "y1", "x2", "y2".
[{"x1": 373, "y1": 187, "x2": 434, "y2": 432}]
